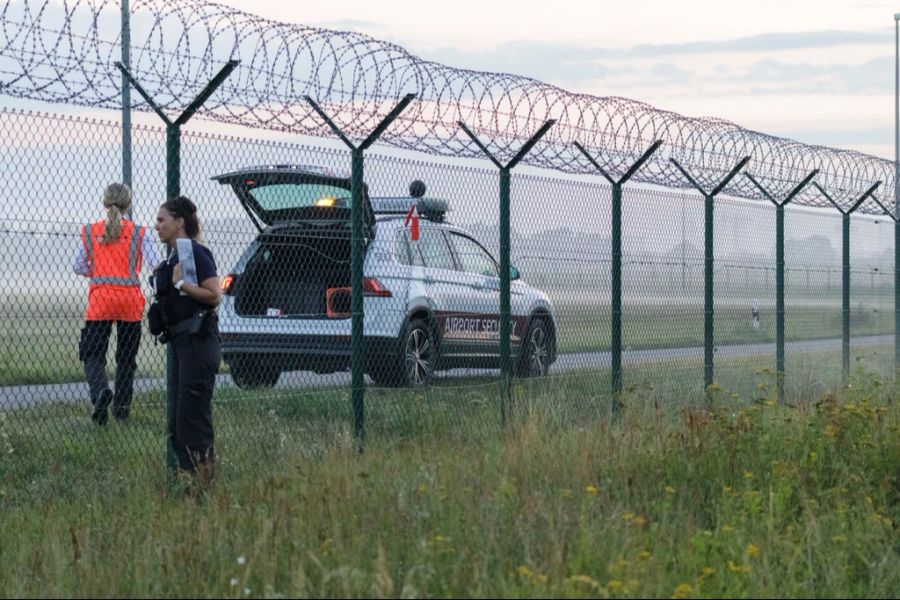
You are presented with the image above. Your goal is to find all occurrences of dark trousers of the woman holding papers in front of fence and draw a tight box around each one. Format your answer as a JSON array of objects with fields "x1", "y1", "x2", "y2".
[{"x1": 168, "y1": 330, "x2": 221, "y2": 471}]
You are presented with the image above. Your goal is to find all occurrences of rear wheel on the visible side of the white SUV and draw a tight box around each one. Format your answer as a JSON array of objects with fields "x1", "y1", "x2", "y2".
[{"x1": 369, "y1": 319, "x2": 437, "y2": 389}]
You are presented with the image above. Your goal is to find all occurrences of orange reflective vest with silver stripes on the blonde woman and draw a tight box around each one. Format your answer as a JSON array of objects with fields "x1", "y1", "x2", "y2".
[{"x1": 81, "y1": 219, "x2": 145, "y2": 321}]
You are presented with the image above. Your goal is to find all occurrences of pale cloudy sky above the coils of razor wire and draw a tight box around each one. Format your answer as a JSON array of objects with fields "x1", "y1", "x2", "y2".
[{"x1": 218, "y1": 0, "x2": 900, "y2": 159}]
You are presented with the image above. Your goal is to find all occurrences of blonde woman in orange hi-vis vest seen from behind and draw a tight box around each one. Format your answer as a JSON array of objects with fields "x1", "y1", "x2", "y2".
[{"x1": 74, "y1": 183, "x2": 160, "y2": 425}]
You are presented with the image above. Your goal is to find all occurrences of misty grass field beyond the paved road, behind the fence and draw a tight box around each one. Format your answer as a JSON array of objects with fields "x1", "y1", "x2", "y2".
[{"x1": 0, "y1": 294, "x2": 894, "y2": 386}]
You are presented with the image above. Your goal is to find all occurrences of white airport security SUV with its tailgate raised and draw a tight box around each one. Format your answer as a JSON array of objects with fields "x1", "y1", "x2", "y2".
[{"x1": 213, "y1": 165, "x2": 556, "y2": 387}]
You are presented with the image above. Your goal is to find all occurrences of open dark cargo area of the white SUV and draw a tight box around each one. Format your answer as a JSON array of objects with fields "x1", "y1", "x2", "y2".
[{"x1": 234, "y1": 231, "x2": 350, "y2": 319}]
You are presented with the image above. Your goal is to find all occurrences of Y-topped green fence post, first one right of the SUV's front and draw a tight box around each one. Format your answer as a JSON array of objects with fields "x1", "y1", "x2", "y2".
[{"x1": 574, "y1": 140, "x2": 662, "y2": 415}]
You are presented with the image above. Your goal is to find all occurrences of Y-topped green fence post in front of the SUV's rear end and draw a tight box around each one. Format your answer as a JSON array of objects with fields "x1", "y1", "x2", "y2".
[{"x1": 304, "y1": 94, "x2": 416, "y2": 452}]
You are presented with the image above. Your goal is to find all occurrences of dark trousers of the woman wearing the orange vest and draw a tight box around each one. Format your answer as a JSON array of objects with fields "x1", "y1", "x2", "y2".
[{"x1": 78, "y1": 321, "x2": 141, "y2": 418}]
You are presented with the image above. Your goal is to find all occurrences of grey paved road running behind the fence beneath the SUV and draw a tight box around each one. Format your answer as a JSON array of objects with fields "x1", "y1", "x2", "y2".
[{"x1": 0, "y1": 335, "x2": 894, "y2": 409}]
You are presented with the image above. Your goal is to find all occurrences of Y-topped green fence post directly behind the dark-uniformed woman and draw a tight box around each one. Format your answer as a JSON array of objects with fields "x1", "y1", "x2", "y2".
[{"x1": 116, "y1": 60, "x2": 239, "y2": 476}]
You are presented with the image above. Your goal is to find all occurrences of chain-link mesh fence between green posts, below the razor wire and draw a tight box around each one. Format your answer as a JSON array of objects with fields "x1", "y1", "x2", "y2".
[{"x1": 0, "y1": 106, "x2": 894, "y2": 489}]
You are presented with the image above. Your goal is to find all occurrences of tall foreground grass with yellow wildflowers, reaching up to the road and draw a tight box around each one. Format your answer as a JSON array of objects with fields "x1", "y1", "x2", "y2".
[{"x1": 0, "y1": 353, "x2": 900, "y2": 597}]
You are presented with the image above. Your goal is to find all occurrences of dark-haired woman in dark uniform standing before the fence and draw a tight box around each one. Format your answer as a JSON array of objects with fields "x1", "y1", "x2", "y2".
[{"x1": 155, "y1": 196, "x2": 221, "y2": 477}]
